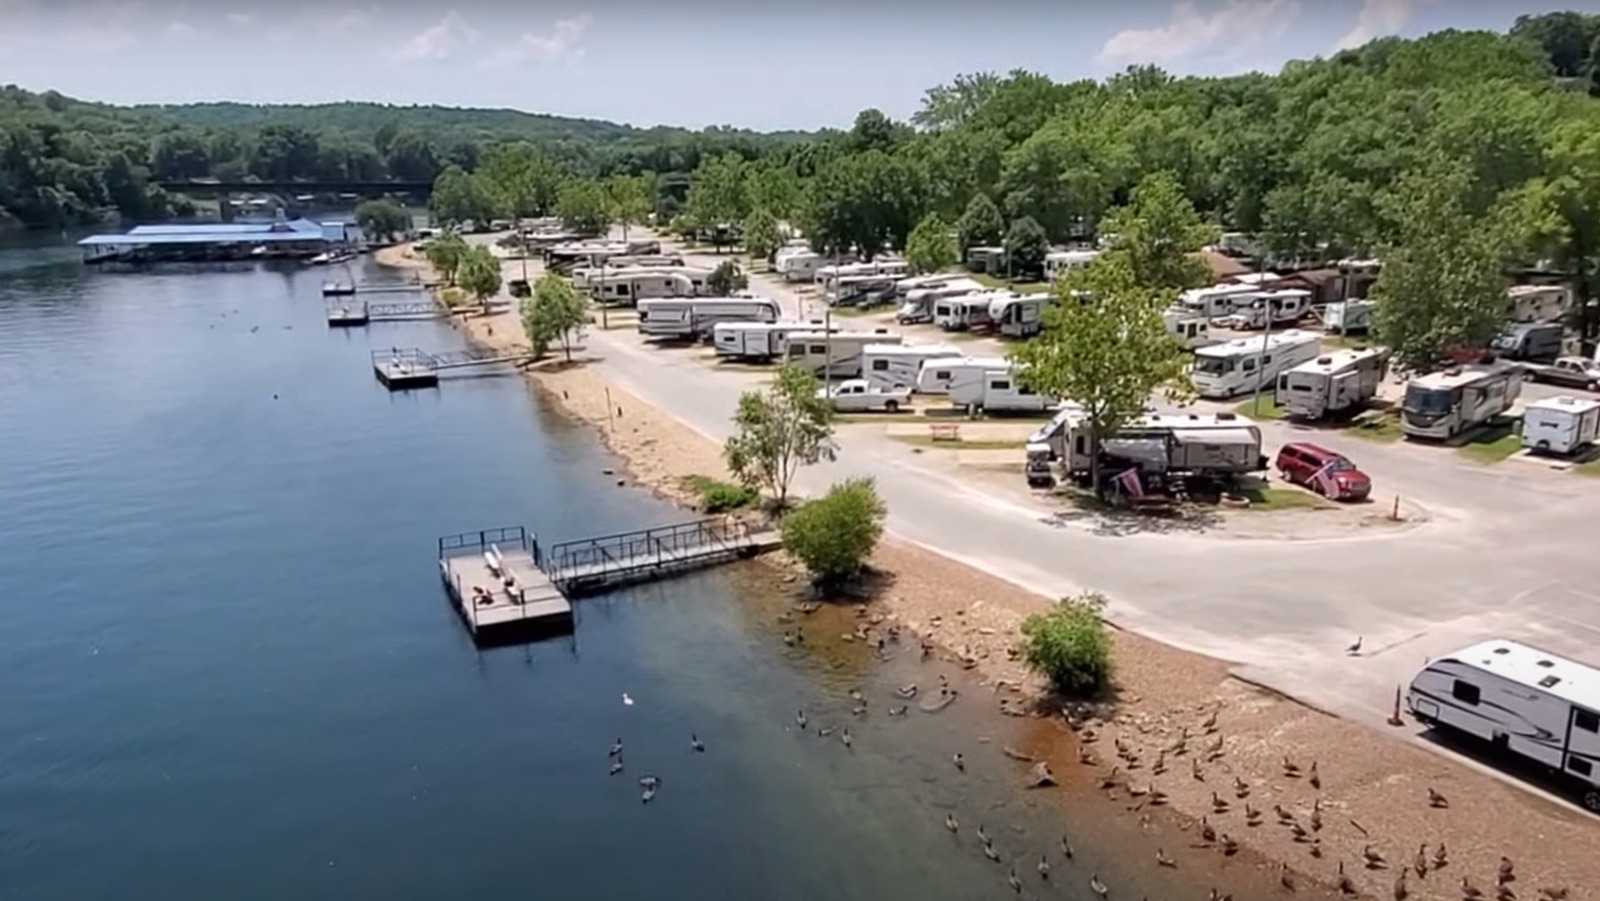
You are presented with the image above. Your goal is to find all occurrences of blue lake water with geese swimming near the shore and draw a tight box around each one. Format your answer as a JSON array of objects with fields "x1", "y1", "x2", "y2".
[{"x1": 0, "y1": 246, "x2": 1286, "y2": 901}]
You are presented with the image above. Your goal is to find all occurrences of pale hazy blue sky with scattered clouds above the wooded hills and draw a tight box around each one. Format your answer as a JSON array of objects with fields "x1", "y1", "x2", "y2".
[{"x1": 0, "y1": 0, "x2": 1600, "y2": 130}]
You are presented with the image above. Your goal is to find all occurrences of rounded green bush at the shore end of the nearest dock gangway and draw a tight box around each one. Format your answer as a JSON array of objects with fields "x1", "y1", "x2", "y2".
[{"x1": 782, "y1": 479, "x2": 888, "y2": 584}]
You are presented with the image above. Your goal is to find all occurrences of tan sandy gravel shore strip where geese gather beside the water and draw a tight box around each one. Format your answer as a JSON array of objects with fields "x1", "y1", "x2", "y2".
[{"x1": 378, "y1": 238, "x2": 1600, "y2": 899}]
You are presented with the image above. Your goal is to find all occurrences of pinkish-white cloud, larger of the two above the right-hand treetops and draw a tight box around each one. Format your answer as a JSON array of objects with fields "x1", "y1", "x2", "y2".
[{"x1": 1096, "y1": 0, "x2": 1305, "y2": 66}]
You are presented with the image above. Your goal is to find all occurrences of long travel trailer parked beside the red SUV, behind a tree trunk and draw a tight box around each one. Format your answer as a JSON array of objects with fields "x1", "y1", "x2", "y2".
[{"x1": 1027, "y1": 405, "x2": 1267, "y2": 482}]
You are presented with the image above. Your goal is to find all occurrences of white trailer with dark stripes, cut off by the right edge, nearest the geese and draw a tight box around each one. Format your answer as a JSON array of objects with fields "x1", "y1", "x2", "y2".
[{"x1": 1406, "y1": 639, "x2": 1600, "y2": 813}]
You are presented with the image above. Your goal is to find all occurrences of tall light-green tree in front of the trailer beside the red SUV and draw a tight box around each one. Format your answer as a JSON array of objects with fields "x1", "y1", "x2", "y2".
[{"x1": 1010, "y1": 253, "x2": 1192, "y2": 495}]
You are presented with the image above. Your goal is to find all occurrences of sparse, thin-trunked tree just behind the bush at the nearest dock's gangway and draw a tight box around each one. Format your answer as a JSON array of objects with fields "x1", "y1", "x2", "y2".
[{"x1": 723, "y1": 365, "x2": 837, "y2": 507}]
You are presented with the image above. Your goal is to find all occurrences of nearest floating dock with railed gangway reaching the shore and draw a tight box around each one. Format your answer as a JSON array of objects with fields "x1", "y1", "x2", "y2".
[{"x1": 438, "y1": 519, "x2": 781, "y2": 643}]
